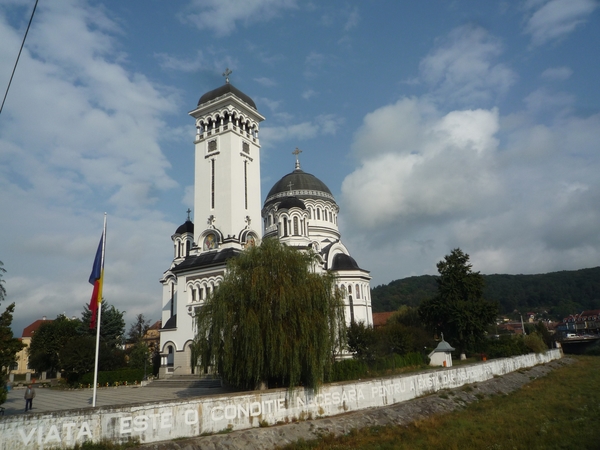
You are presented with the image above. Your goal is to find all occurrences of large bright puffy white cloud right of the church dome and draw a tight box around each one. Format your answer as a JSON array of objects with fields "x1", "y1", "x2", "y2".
[{"x1": 342, "y1": 99, "x2": 499, "y2": 231}]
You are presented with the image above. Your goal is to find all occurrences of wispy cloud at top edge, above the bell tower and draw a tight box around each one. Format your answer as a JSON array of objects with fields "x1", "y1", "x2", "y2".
[{"x1": 180, "y1": 0, "x2": 297, "y2": 36}]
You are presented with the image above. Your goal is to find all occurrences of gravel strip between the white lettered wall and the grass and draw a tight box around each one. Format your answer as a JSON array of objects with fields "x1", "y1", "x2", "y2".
[{"x1": 138, "y1": 357, "x2": 575, "y2": 450}]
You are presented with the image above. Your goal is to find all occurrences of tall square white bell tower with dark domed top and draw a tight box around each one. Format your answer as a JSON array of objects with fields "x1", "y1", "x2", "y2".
[{"x1": 189, "y1": 69, "x2": 264, "y2": 253}]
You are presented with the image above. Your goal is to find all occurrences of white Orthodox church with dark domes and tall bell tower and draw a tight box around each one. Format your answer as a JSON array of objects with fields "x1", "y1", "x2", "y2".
[{"x1": 159, "y1": 76, "x2": 373, "y2": 378}]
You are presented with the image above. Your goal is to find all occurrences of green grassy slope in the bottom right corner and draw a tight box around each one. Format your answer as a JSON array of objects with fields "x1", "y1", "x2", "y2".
[{"x1": 284, "y1": 356, "x2": 600, "y2": 450}]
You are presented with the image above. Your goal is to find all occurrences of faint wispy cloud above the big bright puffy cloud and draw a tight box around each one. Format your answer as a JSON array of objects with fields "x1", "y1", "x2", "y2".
[{"x1": 419, "y1": 25, "x2": 517, "y2": 106}]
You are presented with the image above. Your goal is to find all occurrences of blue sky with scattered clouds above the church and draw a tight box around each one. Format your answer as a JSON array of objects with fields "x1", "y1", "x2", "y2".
[{"x1": 0, "y1": 0, "x2": 600, "y2": 336}]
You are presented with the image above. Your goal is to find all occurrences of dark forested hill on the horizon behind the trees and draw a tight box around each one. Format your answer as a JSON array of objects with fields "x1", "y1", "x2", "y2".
[{"x1": 371, "y1": 267, "x2": 600, "y2": 319}]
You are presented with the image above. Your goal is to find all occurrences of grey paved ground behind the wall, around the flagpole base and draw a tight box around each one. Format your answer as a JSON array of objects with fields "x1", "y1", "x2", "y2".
[{"x1": 2, "y1": 386, "x2": 230, "y2": 415}]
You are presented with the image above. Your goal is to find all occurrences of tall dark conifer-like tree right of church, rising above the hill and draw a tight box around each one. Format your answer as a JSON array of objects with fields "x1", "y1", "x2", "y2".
[{"x1": 419, "y1": 248, "x2": 498, "y2": 353}]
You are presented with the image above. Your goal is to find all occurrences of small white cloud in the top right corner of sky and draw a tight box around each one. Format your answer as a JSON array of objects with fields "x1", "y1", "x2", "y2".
[{"x1": 525, "y1": 0, "x2": 598, "y2": 46}]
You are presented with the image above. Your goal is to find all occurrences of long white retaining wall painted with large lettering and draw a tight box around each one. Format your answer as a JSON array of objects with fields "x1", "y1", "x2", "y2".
[{"x1": 0, "y1": 349, "x2": 561, "y2": 450}]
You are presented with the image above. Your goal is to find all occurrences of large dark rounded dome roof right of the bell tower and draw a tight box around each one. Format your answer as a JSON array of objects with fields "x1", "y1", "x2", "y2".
[{"x1": 265, "y1": 169, "x2": 335, "y2": 206}]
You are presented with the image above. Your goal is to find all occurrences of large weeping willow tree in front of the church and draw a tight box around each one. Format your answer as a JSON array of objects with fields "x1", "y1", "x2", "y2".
[{"x1": 194, "y1": 239, "x2": 345, "y2": 389}]
